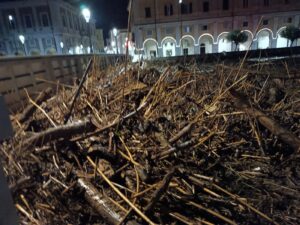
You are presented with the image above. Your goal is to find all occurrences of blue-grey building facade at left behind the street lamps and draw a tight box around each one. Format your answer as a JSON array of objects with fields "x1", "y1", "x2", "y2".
[{"x1": 0, "y1": 0, "x2": 98, "y2": 55}]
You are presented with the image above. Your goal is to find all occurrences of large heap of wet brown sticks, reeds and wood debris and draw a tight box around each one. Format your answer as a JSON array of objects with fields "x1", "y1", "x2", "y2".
[{"x1": 0, "y1": 58, "x2": 300, "y2": 224}]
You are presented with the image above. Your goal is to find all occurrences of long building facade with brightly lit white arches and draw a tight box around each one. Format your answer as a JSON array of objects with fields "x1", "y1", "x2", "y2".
[{"x1": 132, "y1": 0, "x2": 300, "y2": 58}]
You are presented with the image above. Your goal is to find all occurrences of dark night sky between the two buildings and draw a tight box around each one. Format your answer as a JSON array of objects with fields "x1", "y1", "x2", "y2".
[{"x1": 0, "y1": 0, "x2": 128, "y2": 42}]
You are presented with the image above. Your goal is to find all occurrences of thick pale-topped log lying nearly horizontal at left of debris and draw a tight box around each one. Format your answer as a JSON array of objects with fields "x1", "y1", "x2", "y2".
[{"x1": 23, "y1": 119, "x2": 95, "y2": 146}]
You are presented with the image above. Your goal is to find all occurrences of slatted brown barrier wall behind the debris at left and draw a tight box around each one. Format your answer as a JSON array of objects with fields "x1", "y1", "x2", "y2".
[{"x1": 0, "y1": 54, "x2": 124, "y2": 111}]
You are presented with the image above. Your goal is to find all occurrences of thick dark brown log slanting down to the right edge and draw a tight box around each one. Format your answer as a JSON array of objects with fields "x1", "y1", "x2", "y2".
[{"x1": 230, "y1": 90, "x2": 300, "y2": 151}]
